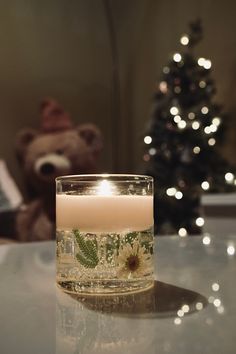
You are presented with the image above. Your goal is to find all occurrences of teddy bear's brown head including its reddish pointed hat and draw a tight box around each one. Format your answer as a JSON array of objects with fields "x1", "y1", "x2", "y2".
[{"x1": 16, "y1": 99, "x2": 102, "y2": 193}]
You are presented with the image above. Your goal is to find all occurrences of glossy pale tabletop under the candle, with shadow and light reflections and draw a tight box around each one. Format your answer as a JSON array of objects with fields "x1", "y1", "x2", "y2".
[{"x1": 0, "y1": 236, "x2": 236, "y2": 354}]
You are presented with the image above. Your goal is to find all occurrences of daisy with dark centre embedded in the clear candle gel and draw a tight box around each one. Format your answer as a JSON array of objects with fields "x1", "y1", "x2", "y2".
[{"x1": 116, "y1": 241, "x2": 152, "y2": 279}]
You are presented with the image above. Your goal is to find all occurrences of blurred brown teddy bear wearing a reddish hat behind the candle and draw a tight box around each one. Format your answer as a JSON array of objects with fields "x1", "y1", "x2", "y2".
[{"x1": 16, "y1": 98, "x2": 102, "y2": 242}]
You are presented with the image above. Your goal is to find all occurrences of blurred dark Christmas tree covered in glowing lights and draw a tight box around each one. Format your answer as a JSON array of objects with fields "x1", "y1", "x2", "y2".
[{"x1": 143, "y1": 20, "x2": 236, "y2": 236}]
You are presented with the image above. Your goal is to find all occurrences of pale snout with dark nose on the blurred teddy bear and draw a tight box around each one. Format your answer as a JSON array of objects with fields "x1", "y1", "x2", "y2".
[{"x1": 35, "y1": 154, "x2": 71, "y2": 179}]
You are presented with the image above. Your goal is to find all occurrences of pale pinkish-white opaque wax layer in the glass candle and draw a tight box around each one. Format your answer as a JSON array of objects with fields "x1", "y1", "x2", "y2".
[{"x1": 56, "y1": 194, "x2": 153, "y2": 233}]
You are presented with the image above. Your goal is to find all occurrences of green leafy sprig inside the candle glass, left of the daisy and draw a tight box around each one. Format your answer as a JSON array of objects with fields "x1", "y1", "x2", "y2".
[{"x1": 73, "y1": 230, "x2": 99, "y2": 268}]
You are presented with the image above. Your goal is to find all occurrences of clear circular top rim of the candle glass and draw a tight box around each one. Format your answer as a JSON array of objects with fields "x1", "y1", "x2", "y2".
[{"x1": 55, "y1": 173, "x2": 154, "y2": 183}]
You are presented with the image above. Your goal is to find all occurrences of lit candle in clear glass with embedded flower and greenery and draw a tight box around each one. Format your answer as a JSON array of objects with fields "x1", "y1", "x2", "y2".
[{"x1": 56, "y1": 174, "x2": 154, "y2": 294}]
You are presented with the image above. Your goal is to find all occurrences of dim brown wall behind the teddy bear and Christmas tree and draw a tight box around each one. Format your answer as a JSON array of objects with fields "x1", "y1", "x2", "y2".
[{"x1": 0, "y1": 0, "x2": 236, "y2": 195}]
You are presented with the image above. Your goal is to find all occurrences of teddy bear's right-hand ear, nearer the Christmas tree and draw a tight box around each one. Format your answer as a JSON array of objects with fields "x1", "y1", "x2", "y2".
[{"x1": 77, "y1": 123, "x2": 102, "y2": 154}]
